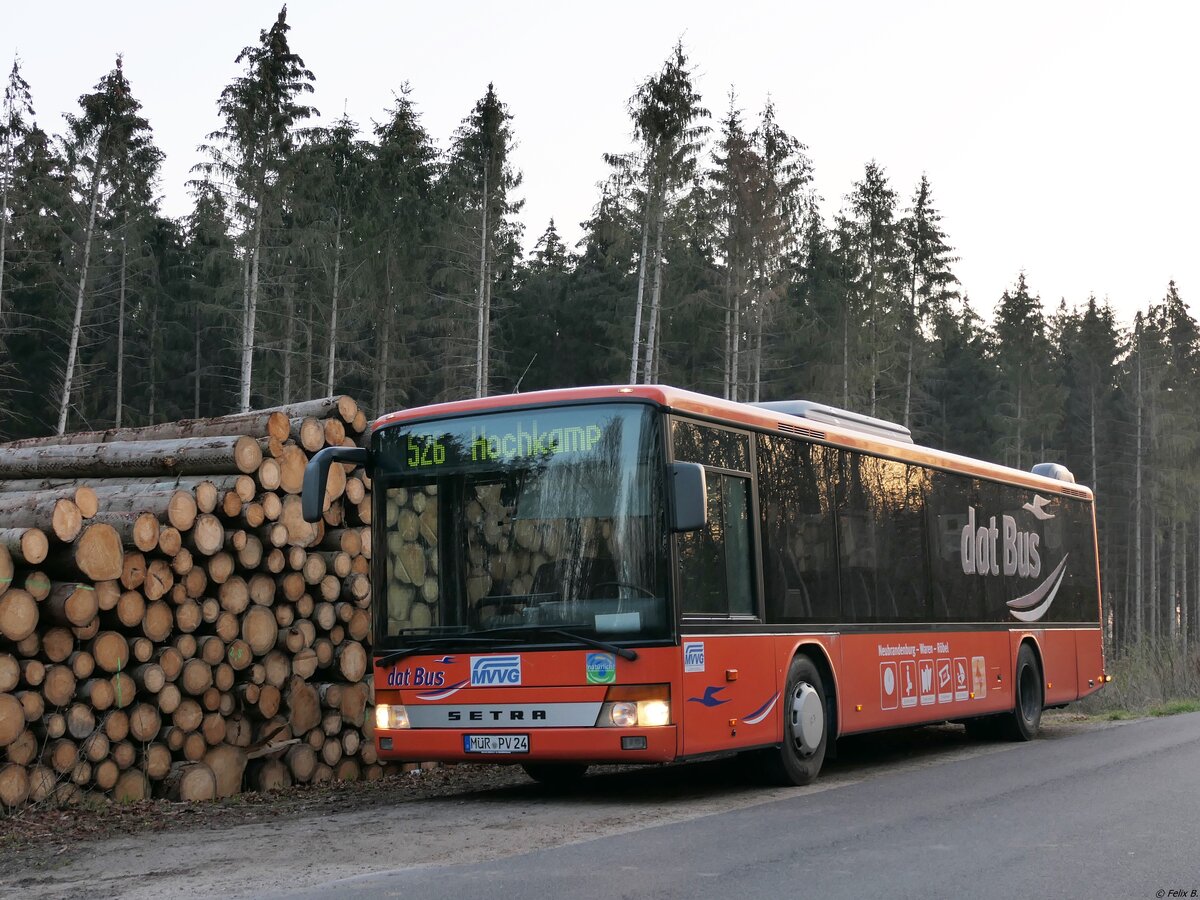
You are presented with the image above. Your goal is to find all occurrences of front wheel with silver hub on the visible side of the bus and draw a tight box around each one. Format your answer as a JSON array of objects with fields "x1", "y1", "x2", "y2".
[{"x1": 763, "y1": 656, "x2": 829, "y2": 785}]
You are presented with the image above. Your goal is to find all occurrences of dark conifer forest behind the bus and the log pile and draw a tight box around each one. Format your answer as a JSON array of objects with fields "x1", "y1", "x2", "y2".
[{"x1": 0, "y1": 10, "x2": 1200, "y2": 656}]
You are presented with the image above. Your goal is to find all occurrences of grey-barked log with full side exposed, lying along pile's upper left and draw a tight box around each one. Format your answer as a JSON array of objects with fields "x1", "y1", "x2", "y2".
[{"x1": 0, "y1": 434, "x2": 263, "y2": 482}]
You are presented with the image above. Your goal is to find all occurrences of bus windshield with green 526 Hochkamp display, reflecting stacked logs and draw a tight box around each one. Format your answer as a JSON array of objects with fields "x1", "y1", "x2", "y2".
[{"x1": 373, "y1": 403, "x2": 672, "y2": 649}]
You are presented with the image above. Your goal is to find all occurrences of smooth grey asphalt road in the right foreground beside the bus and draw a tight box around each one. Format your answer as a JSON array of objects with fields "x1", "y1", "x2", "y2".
[{"x1": 287, "y1": 714, "x2": 1200, "y2": 900}]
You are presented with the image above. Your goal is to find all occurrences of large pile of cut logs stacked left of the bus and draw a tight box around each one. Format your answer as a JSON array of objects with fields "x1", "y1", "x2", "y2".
[{"x1": 0, "y1": 396, "x2": 383, "y2": 806}]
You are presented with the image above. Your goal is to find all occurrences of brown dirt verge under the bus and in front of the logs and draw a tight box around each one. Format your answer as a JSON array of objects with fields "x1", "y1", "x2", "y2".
[{"x1": 0, "y1": 713, "x2": 1116, "y2": 899}]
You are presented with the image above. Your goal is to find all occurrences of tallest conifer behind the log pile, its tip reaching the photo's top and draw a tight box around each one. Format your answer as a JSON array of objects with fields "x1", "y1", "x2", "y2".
[{"x1": 197, "y1": 6, "x2": 317, "y2": 409}]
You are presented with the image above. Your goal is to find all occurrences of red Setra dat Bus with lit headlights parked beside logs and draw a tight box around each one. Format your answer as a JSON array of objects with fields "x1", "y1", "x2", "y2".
[{"x1": 304, "y1": 385, "x2": 1106, "y2": 784}]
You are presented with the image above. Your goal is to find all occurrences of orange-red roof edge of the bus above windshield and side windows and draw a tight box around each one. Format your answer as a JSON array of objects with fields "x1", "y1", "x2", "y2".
[{"x1": 372, "y1": 384, "x2": 1092, "y2": 500}]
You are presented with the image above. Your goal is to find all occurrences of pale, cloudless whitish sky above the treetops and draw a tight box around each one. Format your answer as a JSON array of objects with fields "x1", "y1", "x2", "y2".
[{"x1": 0, "y1": 0, "x2": 1200, "y2": 322}]
